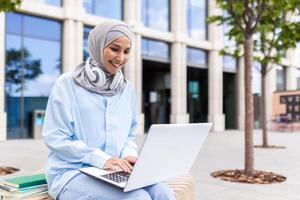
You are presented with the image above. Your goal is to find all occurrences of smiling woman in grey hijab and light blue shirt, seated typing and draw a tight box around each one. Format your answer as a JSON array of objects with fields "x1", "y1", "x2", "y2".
[{"x1": 43, "y1": 21, "x2": 175, "y2": 200}]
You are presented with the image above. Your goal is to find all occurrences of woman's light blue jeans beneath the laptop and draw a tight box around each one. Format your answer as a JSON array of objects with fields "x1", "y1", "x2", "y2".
[{"x1": 57, "y1": 174, "x2": 175, "y2": 200}]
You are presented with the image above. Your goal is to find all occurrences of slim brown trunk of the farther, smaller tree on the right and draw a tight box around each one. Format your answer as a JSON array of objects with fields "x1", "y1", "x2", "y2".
[{"x1": 261, "y1": 64, "x2": 268, "y2": 147}]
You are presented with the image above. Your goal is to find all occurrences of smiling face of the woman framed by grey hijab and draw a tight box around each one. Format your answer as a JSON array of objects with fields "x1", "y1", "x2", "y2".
[{"x1": 102, "y1": 36, "x2": 131, "y2": 74}]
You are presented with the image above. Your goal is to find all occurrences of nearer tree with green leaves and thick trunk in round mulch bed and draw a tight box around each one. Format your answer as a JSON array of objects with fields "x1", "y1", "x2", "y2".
[{"x1": 210, "y1": 0, "x2": 267, "y2": 176}]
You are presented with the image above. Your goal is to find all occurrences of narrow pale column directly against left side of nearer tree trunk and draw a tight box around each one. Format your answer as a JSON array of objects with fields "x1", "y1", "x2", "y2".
[{"x1": 237, "y1": 57, "x2": 245, "y2": 130}]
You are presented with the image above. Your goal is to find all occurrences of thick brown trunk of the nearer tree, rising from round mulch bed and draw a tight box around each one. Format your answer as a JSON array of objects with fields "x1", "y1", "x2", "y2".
[{"x1": 244, "y1": 35, "x2": 254, "y2": 175}]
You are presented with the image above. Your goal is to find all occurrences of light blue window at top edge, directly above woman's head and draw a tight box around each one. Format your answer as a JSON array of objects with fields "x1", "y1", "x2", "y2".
[{"x1": 83, "y1": 0, "x2": 123, "y2": 19}]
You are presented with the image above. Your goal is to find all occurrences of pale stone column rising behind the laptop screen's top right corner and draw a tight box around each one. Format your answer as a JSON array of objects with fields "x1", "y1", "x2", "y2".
[{"x1": 208, "y1": 0, "x2": 225, "y2": 131}]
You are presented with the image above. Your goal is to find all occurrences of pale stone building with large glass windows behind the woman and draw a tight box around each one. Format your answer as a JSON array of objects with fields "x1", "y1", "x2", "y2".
[{"x1": 0, "y1": 0, "x2": 300, "y2": 140}]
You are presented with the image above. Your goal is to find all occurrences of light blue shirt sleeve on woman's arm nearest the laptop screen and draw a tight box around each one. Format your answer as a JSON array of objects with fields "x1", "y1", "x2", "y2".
[{"x1": 121, "y1": 86, "x2": 138, "y2": 158}]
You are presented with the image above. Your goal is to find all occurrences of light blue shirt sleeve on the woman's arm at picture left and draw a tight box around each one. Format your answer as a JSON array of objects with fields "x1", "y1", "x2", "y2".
[{"x1": 43, "y1": 79, "x2": 111, "y2": 168}]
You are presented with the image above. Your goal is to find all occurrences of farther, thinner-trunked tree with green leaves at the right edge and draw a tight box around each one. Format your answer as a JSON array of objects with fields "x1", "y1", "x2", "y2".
[{"x1": 254, "y1": 0, "x2": 300, "y2": 147}]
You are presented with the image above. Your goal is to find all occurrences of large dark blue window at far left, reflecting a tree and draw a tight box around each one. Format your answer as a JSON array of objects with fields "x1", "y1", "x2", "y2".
[{"x1": 5, "y1": 13, "x2": 61, "y2": 138}]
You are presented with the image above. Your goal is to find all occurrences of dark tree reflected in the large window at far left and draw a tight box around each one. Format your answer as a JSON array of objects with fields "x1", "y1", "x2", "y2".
[{"x1": 5, "y1": 48, "x2": 42, "y2": 96}]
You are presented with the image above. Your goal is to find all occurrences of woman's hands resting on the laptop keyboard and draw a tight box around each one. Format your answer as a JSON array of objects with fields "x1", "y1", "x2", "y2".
[{"x1": 104, "y1": 157, "x2": 132, "y2": 172}]
